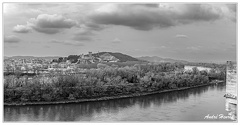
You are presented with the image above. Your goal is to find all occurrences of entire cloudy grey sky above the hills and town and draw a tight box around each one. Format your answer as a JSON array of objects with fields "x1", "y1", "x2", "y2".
[{"x1": 3, "y1": 3, "x2": 237, "y2": 62}]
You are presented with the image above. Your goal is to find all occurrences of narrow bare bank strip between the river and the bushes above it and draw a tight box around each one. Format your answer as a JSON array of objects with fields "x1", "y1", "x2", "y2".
[{"x1": 4, "y1": 83, "x2": 219, "y2": 106}]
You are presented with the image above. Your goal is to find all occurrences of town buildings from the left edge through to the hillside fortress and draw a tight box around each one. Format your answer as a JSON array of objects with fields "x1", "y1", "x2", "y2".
[{"x1": 4, "y1": 52, "x2": 120, "y2": 73}]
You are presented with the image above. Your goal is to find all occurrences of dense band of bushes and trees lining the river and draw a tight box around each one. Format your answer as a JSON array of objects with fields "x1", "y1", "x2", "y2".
[{"x1": 4, "y1": 63, "x2": 225, "y2": 104}]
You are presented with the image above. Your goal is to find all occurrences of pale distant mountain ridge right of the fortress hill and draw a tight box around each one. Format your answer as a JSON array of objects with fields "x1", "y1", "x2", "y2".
[{"x1": 137, "y1": 56, "x2": 188, "y2": 63}]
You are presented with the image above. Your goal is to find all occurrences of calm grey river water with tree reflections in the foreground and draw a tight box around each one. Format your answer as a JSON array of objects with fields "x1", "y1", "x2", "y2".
[{"x1": 4, "y1": 83, "x2": 236, "y2": 122}]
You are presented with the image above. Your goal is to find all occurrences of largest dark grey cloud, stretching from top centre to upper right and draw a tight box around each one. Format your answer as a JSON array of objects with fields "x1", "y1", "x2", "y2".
[{"x1": 89, "y1": 4, "x2": 225, "y2": 30}]
